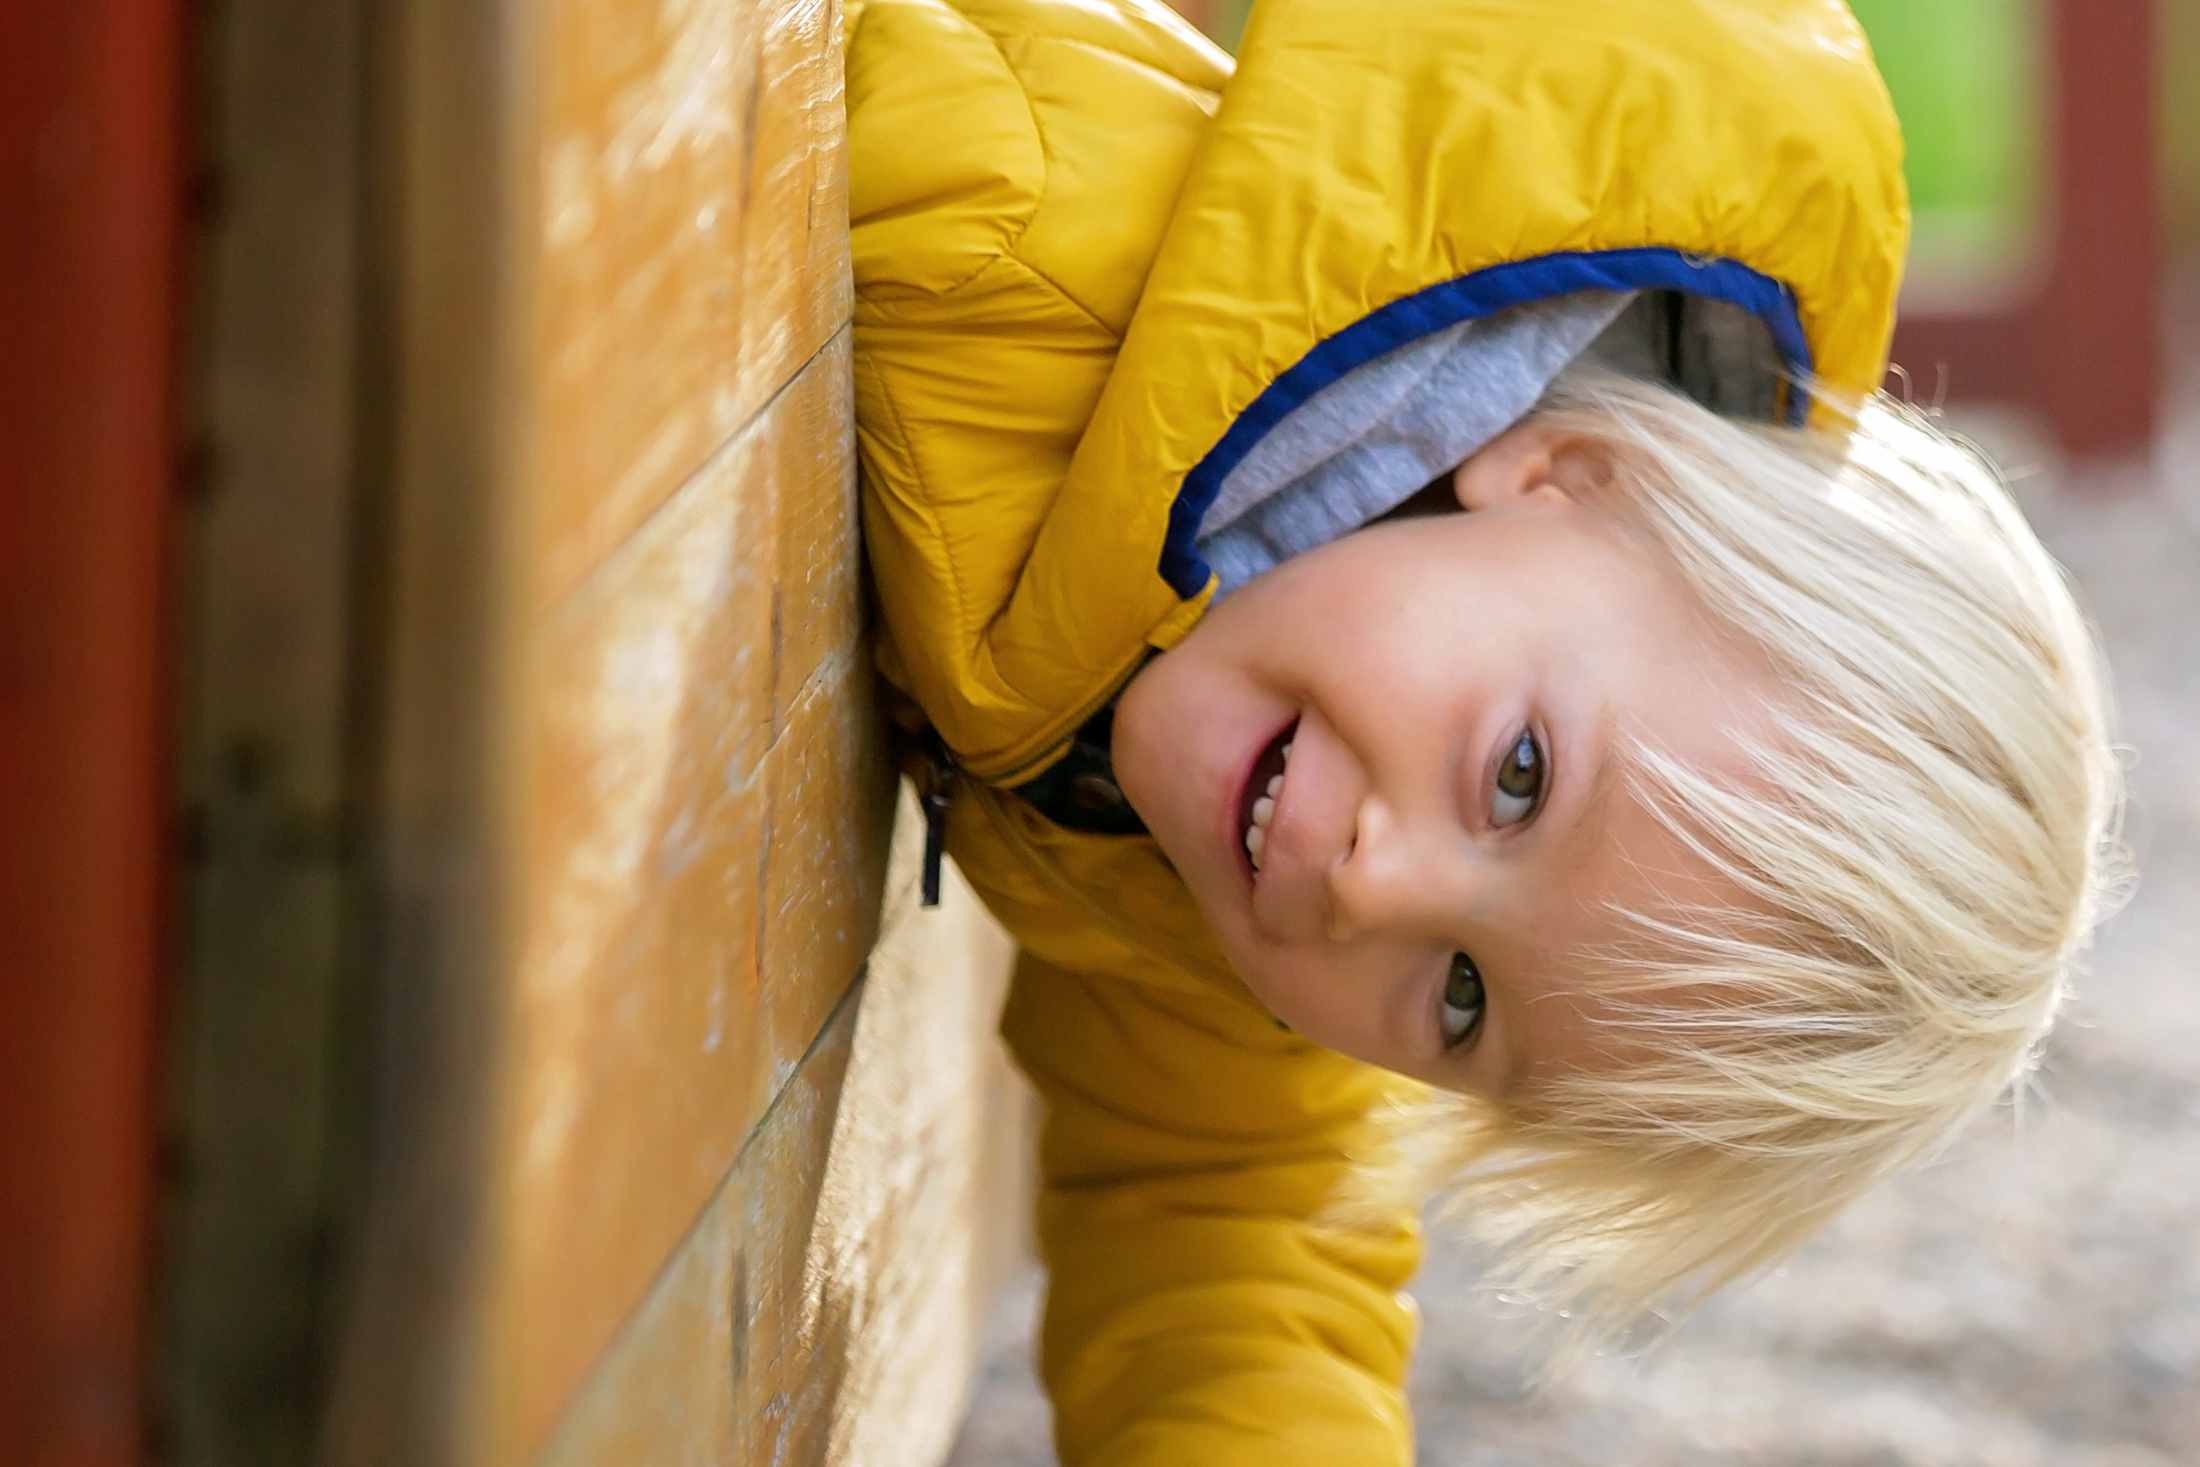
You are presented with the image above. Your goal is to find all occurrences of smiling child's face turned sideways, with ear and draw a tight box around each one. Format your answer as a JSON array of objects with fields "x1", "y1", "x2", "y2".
[{"x1": 1115, "y1": 424, "x2": 1773, "y2": 1095}]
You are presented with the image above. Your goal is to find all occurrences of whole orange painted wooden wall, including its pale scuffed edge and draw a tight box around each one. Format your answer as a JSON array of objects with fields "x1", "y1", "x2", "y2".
[{"x1": 323, "y1": 0, "x2": 1023, "y2": 1467}]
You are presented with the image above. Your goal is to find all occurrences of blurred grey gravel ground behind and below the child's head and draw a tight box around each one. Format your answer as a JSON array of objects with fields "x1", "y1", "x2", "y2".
[{"x1": 950, "y1": 391, "x2": 2200, "y2": 1467}]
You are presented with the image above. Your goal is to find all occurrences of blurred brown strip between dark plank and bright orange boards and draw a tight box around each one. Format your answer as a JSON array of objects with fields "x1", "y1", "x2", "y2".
[{"x1": 319, "y1": 0, "x2": 537, "y2": 1467}]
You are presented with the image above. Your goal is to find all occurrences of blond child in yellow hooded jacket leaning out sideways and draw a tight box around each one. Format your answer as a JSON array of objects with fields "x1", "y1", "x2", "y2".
[{"x1": 849, "y1": 0, "x2": 2116, "y2": 1467}]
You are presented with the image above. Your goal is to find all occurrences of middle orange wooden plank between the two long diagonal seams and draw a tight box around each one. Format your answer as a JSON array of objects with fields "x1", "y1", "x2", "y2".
[{"x1": 497, "y1": 334, "x2": 891, "y2": 1441}]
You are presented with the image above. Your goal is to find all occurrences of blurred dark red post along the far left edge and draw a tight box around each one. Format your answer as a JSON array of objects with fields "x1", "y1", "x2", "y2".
[{"x1": 0, "y1": 0, "x2": 183, "y2": 1467}]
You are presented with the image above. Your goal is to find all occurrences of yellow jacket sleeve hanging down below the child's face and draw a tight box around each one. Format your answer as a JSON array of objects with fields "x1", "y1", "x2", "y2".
[{"x1": 1001, "y1": 955, "x2": 1419, "y2": 1467}]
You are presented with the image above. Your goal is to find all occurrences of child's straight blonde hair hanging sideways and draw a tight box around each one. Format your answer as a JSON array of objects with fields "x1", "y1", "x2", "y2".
[{"x1": 1390, "y1": 374, "x2": 2121, "y2": 1357}]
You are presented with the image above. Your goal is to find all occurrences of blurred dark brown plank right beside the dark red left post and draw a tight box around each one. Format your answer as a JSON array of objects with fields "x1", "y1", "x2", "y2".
[{"x1": 154, "y1": 0, "x2": 363, "y2": 1467}]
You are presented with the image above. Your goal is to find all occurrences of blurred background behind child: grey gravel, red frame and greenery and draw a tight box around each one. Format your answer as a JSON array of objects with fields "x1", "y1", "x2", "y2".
[{"x1": 950, "y1": 0, "x2": 2200, "y2": 1467}]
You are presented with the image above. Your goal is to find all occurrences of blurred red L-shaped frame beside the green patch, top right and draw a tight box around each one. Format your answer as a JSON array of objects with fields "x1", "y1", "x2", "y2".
[{"x1": 1894, "y1": 0, "x2": 2163, "y2": 457}]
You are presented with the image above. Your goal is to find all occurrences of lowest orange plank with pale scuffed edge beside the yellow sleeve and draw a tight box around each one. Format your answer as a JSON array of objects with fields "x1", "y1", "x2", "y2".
[{"x1": 546, "y1": 794, "x2": 1030, "y2": 1467}]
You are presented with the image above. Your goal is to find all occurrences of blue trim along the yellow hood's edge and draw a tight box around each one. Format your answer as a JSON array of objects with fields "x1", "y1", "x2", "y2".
[{"x1": 1159, "y1": 249, "x2": 1811, "y2": 600}]
